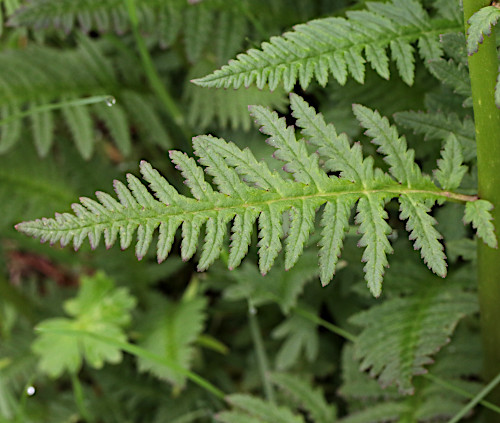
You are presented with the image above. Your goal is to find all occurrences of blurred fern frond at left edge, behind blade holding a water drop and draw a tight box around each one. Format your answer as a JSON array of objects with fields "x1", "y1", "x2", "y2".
[{"x1": 0, "y1": 39, "x2": 161, "y2": 159}]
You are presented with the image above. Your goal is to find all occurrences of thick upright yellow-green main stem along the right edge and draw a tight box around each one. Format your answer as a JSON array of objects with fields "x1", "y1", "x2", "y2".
[{"x1": 464, "y1": 0, "x2": 500, "y2": 414}]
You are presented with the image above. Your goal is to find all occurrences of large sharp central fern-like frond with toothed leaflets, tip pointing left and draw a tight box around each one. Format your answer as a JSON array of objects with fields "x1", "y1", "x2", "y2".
[{"x1": 16, "y1": 94, "x2": 497, "y2": 296}]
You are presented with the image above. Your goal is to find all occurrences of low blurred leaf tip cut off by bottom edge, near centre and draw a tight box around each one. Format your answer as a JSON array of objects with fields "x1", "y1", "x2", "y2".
[{"x1": 217, "y1": 394, "x2": 304, "y2": 423}]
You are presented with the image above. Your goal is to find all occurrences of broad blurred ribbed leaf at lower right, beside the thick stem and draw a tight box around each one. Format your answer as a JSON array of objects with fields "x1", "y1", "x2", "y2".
[{"x1": 350, "y1": 279, "x2": 478, "y2": 395}]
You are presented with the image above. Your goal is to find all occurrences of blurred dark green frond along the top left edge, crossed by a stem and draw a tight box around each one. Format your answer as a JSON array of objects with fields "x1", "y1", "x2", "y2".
[{"x1": 8, "y1": 0, "x2": 241, "y2": 63}]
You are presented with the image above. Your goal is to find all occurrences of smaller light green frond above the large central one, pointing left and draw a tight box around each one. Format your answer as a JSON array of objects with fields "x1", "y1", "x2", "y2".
[{"x1": 194, "y1": 0, "x2": 461, "y2": 91}]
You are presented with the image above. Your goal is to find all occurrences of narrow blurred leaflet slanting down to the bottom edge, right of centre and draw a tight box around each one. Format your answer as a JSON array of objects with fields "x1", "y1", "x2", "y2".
[{"x1": 271, "y1": 373, "x2": 337, "y2": 423}]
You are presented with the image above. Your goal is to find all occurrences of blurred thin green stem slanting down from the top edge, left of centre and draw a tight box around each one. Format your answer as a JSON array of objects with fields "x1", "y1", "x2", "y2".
[{"x1": 126, "y1": 0, "x2": 190, "y2": 138}]
